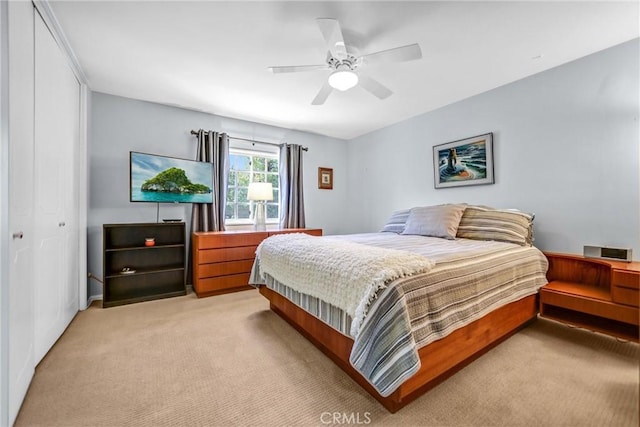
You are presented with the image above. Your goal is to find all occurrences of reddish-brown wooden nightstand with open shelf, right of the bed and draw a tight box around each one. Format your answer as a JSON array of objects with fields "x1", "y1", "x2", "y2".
[{"x1": 540, "y1": 253, "x2": 640, "y2": 342}]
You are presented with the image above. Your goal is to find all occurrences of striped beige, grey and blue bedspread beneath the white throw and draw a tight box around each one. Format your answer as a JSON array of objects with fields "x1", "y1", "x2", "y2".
[{"x1": 252, "y1": 233, "x2": 547, "y2": 396}]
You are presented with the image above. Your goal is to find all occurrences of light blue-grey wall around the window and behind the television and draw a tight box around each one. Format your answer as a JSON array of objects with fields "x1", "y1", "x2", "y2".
[{"x1": 87, "y1": 92, "x2": 349, "y2": 296}]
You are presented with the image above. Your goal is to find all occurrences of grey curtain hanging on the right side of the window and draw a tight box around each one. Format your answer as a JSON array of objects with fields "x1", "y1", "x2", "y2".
[{"x1": 280, "y1": 144, "x2": 305, "y2": 228}]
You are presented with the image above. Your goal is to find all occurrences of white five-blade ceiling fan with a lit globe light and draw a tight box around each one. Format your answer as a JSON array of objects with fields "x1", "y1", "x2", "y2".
[{"x1": 269, "y1": 18, "x2": 422, "y2": 105}]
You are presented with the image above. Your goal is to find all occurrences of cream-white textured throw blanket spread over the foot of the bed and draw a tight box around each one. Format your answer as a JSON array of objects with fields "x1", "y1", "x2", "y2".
[{"x1": 256, "y1": 233, "x2": 435, "y2": 337}]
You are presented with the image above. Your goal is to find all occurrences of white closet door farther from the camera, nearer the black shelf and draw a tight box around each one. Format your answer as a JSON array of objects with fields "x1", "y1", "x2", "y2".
[{"x1": 34, "y1": 10, "x2": 80, "y2": 363}]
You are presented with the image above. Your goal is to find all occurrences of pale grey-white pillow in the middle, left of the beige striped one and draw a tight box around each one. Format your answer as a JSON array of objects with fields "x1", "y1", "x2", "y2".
[{"x1": 402, "y1": 204, "x2": 467, "y2": 240}]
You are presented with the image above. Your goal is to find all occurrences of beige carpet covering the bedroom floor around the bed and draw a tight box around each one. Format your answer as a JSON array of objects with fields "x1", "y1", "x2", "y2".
[{"x1": 16, "y1": 291, "x2": 640, "y2": 426}]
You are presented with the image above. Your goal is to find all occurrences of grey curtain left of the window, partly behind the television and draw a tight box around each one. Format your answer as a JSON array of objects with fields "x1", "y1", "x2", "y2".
[{"x1": 191, "y1": 129, "x2": 229, "y2": 233}]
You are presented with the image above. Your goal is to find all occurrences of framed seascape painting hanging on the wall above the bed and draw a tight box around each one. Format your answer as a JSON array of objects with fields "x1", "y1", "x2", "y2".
[{"x1": 433, "y1": 132, "x2": 494, "y2": 188}]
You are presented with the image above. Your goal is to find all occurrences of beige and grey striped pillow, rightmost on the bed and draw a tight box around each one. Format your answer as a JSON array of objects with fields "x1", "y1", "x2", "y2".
[{"x1": 456, "y1": 206, "x2": 534, "y2": 246}]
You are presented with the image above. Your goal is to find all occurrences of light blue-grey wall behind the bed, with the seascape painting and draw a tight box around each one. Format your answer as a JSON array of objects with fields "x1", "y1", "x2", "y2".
[{"x1": 348, "y1": 39, "x2": 640, "y2": 259}]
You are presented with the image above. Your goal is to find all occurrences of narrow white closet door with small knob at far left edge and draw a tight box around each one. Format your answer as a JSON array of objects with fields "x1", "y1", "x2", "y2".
[{"x1": 8, "y1": 2, "x2": 35, "y2": 424}]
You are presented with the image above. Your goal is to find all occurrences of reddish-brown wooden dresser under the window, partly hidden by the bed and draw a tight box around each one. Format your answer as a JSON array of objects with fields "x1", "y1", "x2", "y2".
[{"x1": 191, "y1": 228, "x2": 322, "y2": 297}]
